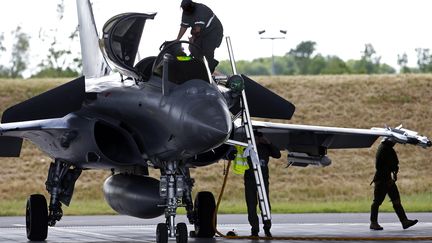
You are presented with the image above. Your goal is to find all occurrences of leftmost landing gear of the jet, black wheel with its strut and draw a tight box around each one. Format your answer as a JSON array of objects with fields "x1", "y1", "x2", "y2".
[{"x1": 26, "y1": 160, "x2": 82, "y2": 241}]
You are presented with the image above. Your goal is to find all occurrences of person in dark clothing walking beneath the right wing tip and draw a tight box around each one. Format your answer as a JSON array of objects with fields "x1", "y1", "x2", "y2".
[{"x1": 370, "y1": 138, "x2": 418, "y2": 230}]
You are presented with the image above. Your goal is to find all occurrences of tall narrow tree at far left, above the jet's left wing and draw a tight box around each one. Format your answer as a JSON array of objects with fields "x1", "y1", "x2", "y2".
[{"x1": 9, "y1": 26, "x2": 30, "y2": 78}]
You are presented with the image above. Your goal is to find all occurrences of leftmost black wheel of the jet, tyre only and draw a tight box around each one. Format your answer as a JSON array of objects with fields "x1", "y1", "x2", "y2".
[{"x1": 26, "y1": 194, "x2": 48, "y2": 241}]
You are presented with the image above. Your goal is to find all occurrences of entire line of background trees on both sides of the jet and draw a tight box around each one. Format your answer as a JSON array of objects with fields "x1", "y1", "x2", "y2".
[{"x1": 0, "y1": 0, "x2": 432, "y2": 78}]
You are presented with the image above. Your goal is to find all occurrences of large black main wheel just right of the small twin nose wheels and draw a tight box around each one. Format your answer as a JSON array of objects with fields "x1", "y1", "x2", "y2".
[{"x1": 194, "y1": 191, "x2": 216, "y2": 238}]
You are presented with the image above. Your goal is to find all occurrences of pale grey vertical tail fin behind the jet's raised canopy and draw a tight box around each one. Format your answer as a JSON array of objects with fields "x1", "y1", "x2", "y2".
[{"x1": 76, "y1": 0, "x2": 111, "y2": 78}]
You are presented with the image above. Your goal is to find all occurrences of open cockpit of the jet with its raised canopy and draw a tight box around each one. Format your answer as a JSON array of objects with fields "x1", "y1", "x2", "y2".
[{"x1": 100, "y1": 13, "x2": 211, "y2": 84}]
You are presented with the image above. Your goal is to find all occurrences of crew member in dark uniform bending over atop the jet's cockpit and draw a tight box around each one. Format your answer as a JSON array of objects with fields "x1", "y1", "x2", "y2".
[{"x1": 176, "y1": 0, "x2": 223, "y2": 73}]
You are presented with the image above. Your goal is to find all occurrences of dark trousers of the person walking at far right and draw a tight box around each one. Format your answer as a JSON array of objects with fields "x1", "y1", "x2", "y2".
[{"x1": 370, "y1": 181, "x2": 407, "y2": 222}]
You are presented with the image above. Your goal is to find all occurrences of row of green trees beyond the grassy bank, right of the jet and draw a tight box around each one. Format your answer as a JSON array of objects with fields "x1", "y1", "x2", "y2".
[{"x1": 217, "y1": 41, "x2": 432, "y2": 75}]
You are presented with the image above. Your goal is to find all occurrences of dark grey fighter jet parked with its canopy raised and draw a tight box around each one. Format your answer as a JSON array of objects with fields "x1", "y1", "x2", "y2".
[{"x1": 0, "y1": 0, "x2": 431, "y2": 243}]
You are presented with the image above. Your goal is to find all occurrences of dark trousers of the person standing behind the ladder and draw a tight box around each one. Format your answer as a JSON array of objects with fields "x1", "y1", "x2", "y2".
[{"x1": 244, "y1": 167, "x2": 271, "y2": 233}]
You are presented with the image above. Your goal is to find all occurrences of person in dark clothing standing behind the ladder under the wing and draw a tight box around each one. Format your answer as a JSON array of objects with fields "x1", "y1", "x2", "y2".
[{"x1": 244, "y1": 132, "x2": 281, "y2": 237}]
